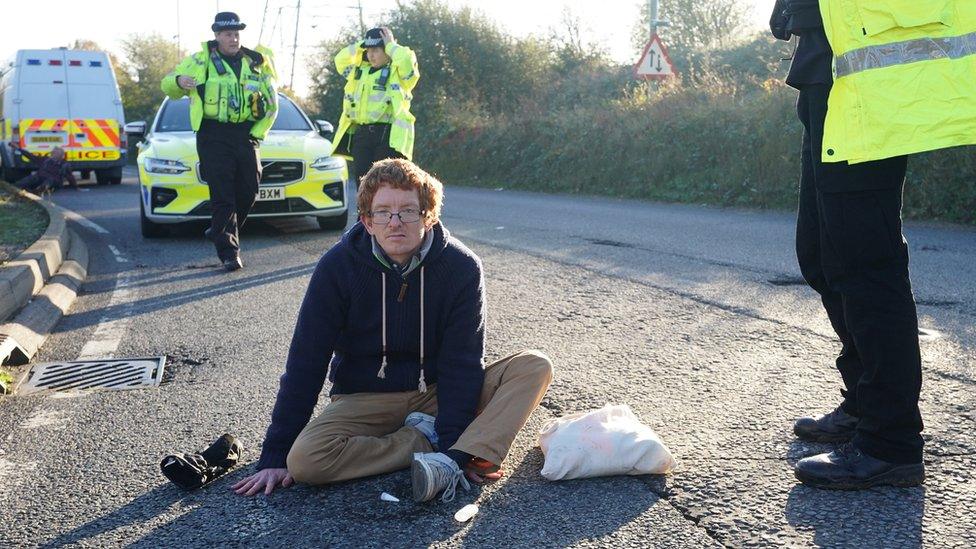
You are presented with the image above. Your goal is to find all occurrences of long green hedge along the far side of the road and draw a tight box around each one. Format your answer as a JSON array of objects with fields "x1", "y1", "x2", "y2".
[{"x1": 417, "y1": 80, "x2": 976, "y2": 224}]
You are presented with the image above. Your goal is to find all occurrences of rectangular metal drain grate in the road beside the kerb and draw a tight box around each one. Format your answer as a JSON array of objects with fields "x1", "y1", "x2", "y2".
[{"x1": 17, "y1": 356, "x2": 166, "y2": 395}]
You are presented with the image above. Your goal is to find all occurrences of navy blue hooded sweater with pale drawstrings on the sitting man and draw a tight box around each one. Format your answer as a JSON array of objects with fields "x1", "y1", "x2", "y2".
[{"x1": 258, "y1": 223, "x2": 485, "y2": 469}]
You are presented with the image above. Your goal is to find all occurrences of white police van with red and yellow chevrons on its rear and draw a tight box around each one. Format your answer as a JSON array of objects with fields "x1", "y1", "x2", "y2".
[{"x1": 0, "y1": 48, "x2": 126, "y2": 184}]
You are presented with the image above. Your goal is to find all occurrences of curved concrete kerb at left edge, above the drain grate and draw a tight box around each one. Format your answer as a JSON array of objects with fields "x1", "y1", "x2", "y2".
[{"x1": 0, "y1": 182, "x2": 88, "y2": 366}]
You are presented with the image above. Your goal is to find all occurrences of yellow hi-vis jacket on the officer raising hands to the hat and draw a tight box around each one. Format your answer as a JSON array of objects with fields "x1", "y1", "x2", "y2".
[{"x1": 332, "y1": 42, "x2": 420, "y2": 159}]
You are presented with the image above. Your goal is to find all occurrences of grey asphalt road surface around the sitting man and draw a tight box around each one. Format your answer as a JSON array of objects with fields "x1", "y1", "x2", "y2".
[{"x1": 0, "y1": 166, "x2": 976, "y2": 547}]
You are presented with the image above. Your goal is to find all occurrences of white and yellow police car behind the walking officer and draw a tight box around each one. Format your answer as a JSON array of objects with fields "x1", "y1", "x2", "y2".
[{"x1": 125, "y1": 94, "x2": 349, "y2": 238}]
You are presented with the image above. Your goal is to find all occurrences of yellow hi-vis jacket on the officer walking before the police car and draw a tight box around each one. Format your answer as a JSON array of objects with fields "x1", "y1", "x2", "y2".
[{"x1": 160, "y1": 41, "x2": 278, "y2": 139}]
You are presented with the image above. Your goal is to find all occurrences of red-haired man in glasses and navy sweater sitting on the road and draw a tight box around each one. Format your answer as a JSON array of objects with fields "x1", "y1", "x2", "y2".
[{"x1": 233, "y1": 159, "x2": 552, "y2": 501}]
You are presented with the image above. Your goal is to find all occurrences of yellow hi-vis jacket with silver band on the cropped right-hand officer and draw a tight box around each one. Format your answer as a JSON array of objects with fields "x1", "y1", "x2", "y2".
[{"x1": 820, "y1": 0, "x2": 976, "y2": 164}]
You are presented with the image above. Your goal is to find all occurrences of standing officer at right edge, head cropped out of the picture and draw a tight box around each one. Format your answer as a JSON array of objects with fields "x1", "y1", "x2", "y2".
[{"x1": 770, "y1": 0, "x2": 976, "y2": 490}]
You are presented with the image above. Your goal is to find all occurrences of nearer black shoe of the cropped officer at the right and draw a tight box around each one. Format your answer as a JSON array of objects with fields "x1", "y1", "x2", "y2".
[{"x1": 793, "y1": 443, "x2": 925, "y2": 490}]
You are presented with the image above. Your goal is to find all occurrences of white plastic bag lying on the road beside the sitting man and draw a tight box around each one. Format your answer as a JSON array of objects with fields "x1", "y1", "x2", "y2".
[{"x1": 539, "y1": 404, "x2": 675, "y2": 480}]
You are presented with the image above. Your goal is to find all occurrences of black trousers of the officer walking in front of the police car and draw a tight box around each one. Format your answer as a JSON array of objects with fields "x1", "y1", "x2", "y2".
[{"x1": 197, "y1": 132, "x2": 261, "y2": 261}]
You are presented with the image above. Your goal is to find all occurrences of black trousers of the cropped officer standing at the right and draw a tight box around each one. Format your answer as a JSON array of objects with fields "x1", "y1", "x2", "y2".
[{"x1": 796, "y1": 85, "x2": 922, "y2": 463}]
